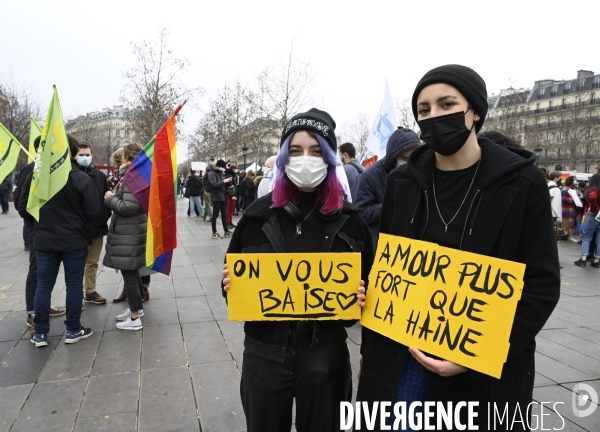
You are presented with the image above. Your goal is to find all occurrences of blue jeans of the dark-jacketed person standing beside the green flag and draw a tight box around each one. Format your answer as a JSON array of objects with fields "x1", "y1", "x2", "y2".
[{"x1": 33, "y1": 248, "x2": 87, "y2": 334}]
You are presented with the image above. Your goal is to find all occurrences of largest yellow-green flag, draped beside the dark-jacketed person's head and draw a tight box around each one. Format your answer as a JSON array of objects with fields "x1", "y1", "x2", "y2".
[{"x1": 27, "y1": 86, "x2": 71, "y2": 221}]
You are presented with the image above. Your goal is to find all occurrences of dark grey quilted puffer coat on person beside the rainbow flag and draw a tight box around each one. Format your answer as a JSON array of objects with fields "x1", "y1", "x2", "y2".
[{"x1": 103, "y1": 169, "x2": 148, "y2": 270}]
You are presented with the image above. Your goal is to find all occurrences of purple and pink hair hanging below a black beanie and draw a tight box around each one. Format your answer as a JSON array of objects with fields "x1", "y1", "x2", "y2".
[{"x1": 271, "y1": 131, "x2": 344, "y2": 213}]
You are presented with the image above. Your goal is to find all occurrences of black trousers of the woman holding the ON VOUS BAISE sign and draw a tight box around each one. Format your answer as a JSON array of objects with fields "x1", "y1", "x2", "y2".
[{"x1": 240, "y1": 332, "x2": 352, "y2": 432}]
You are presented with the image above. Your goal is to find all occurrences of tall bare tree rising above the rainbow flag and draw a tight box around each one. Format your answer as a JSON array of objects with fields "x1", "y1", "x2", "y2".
[{"x1": 121, "y1": 28, "x2": 204, "y2": 144}]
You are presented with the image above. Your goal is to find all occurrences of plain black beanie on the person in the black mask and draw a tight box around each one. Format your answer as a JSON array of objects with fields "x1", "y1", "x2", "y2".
[{"x1": 412, "y1": 65, "x2": 488, "y2": 132}]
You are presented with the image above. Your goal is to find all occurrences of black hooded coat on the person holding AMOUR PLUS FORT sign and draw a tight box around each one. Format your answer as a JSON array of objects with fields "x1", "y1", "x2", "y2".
[{"x1": 357, "y1": 139, "x2": 560, "y2": 430}]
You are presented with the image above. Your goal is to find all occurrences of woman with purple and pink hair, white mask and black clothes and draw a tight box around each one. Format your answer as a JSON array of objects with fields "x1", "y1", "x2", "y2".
[{"x1": 222, "y1": 108, "x2": 374, "y2": 432}]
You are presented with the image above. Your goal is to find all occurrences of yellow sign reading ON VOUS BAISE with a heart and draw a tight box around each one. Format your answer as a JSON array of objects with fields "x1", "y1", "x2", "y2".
[{"x1": 226, "y1": 253, "x2": 361, "y2": 321}]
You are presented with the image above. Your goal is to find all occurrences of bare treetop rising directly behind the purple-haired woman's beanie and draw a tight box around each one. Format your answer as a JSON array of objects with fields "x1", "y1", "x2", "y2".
[{"x1": 258, "y1": 41, "x2": 314, "y2": 132}]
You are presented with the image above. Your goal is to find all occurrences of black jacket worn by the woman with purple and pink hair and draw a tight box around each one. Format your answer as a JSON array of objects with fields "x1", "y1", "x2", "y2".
[{"x1": 223, "y1": 194, "x2": 374, "y2": 361}]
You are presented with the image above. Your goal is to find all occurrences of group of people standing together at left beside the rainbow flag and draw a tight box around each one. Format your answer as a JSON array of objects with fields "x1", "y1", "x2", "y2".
[{"x1": 7, "y1": 135, "x2": 150, "y2": 347}]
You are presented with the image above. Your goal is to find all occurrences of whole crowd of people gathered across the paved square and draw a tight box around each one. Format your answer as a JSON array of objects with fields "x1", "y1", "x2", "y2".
[{"x1": 0, "y1": 65, "x2": 600, "y2": 432}]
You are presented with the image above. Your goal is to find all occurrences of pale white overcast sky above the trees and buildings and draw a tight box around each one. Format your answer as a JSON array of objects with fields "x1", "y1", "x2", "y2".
[{"x1": 0, "y1": 0, "x2": 600, "y2": 158}]
